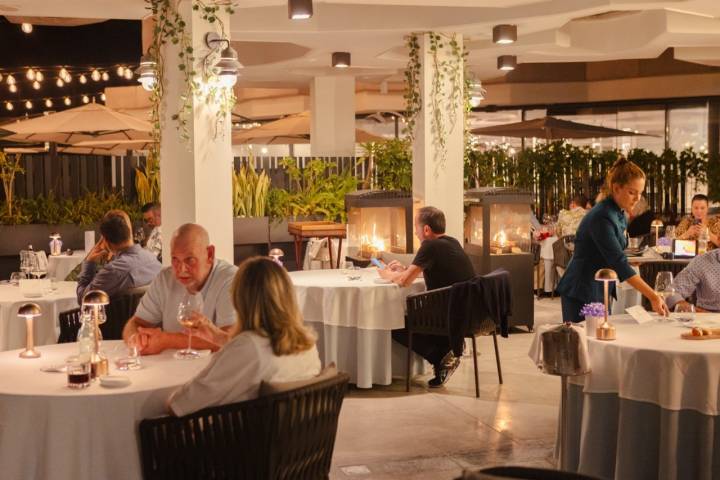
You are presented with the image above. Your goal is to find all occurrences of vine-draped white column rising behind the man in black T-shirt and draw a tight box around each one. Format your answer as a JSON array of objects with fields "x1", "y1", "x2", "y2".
[{"x1": 413, "y1": 34, "x2": 464, "y2": 243}]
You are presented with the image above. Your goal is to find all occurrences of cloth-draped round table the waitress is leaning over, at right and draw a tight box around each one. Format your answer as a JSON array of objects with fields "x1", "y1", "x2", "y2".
[{"x1": 563, "y1": 314, "x2": 720, "y2": 480}]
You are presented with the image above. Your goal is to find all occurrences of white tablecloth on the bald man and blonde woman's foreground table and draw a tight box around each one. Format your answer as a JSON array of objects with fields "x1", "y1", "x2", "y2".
[{"x1": 0, "y1": 341, "x2": 214, "y2": 480}]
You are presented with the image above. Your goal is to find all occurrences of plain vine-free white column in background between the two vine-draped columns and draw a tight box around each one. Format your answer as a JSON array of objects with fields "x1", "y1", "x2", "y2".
[{"x1": 310, "y1": 75, "x2": 355, "y2": 157}]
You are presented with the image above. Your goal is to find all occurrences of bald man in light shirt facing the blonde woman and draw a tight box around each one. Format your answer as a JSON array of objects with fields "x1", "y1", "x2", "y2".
[{"x1": 123, "y1": 223, "x2": 237, "y2": 355}]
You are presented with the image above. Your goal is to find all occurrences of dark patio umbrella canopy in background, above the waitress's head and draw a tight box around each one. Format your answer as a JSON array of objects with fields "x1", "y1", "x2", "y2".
[{"x1": 470, "y1": 117, "x2": 650, "y2": 140}]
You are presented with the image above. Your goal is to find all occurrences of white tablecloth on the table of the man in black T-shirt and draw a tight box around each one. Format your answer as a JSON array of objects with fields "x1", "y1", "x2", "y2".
[{"x1": 290, "y1": 269, "x2": 425, "y2": 388}]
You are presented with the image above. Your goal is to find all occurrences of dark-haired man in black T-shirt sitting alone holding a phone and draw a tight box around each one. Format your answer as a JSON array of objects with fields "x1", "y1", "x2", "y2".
[{"x1": 378, "y1": 207, "x2": 475, "y2": 388}]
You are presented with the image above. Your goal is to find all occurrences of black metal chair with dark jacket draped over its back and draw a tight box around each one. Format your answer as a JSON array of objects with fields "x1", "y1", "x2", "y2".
[{"x1": 405, "y1": 287, "x2": 503, "y2": 398}]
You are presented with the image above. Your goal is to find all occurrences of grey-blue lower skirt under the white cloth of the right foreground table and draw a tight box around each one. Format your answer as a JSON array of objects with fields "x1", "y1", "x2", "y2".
[{"x1": 563, "y1": 384, "x2": 720, "y2": 480}]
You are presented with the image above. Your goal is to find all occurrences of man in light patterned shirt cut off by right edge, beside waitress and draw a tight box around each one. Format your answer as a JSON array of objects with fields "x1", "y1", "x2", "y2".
[{"x1": 666, "y1": 248, "x2": 720, "y2": 312}]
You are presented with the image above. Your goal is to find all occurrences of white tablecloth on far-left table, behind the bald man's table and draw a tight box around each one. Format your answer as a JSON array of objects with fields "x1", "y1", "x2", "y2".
[{"x1": 0, "y1": 282, "x2": 78, "y2": 351}]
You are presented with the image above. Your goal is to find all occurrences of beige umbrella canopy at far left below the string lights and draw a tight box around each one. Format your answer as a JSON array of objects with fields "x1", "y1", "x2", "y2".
[{"x1": 2, "y1": 103, "x2": 152, "y2": 144}]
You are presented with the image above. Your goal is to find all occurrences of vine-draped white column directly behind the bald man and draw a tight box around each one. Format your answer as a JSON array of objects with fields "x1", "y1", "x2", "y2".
[{"x1": 160, "y1": 0, "x2": 233, "y2": 265}]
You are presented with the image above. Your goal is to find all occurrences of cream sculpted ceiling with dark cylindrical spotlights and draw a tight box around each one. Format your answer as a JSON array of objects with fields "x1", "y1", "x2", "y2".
[{"x1": 0, "y1": 0, "x2": 720, "y2": 87}]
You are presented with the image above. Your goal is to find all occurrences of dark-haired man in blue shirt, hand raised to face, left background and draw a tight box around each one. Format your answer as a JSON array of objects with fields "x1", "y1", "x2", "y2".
[{"x1": 77, "y1": 210, "x2": 162, "y2": 303}]
